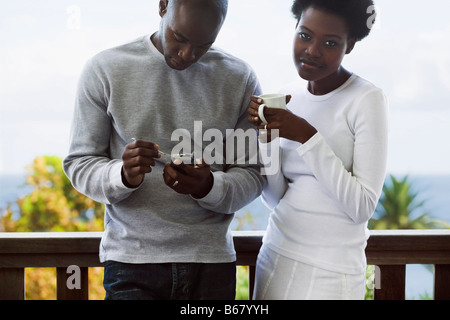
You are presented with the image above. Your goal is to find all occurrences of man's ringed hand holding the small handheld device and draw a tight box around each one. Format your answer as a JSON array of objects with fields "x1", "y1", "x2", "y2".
[{"x1": 163, "y1": 159, "x2": 214, "y2": 199}]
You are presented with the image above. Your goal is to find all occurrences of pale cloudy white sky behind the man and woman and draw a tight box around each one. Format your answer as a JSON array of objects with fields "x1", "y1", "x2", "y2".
[{"x1": 0, "y1": 0, "x2": 450, "y2": 175}]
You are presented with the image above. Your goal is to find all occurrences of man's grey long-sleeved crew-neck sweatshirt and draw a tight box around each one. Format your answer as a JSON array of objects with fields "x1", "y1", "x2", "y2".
[{"x1": 63, "y1": 36, "x2": 265, "y2": 263}]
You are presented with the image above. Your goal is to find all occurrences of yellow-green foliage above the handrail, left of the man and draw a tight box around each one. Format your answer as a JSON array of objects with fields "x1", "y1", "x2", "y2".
[{"x1": 1, "y1": 156, "x2": 104, "y2": 232}]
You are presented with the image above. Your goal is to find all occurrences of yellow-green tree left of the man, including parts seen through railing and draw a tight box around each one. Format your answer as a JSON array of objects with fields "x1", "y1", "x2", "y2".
[{"x1": 0, "y1": 156, "x2": 105, "y2": 300}]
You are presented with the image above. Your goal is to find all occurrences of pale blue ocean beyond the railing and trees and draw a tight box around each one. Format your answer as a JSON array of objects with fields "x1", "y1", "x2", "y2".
[{"x1": 0, "y1": 175, "x2": 450, "y2": 299}]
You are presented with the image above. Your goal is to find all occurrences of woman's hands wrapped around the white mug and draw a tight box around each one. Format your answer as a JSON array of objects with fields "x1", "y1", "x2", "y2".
[{"x1": 248, "y1": 95, "x2": 317, "y2": 143}]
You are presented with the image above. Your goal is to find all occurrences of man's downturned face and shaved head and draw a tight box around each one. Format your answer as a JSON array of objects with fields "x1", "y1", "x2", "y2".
[{"x1": 155, "y1": 1, "x2": 224, "y2": 70}]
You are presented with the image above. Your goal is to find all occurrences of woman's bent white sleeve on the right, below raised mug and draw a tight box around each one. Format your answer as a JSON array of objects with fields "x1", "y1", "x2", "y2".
[{"x1": 297, "y1": 89, "x2": 388, "y2": 223}]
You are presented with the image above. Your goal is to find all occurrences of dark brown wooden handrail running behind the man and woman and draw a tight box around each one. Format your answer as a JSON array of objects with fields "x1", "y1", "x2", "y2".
[{"x1": 0, "y1": 229, "x2": 450, "y2": 267}]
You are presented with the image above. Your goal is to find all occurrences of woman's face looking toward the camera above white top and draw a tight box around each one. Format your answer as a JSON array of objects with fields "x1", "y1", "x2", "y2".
[{"x1": 294, "y1": 7, "x2": 356, "y2": 82}]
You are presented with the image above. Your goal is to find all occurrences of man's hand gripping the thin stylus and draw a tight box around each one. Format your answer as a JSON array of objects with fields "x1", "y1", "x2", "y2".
[{"x1": 122, "y1": 140, "x2": 161, "y2": 188}]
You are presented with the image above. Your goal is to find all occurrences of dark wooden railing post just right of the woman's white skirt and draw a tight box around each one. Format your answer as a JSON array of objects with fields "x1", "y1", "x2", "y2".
[{"x1": 373, "y1": 264, "x2": 406, "y2": 300}]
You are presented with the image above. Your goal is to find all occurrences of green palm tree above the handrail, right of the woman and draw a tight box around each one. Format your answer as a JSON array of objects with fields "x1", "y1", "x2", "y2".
[{"x1": 369, "y1": 175, "x2": 449, "y2": 229}]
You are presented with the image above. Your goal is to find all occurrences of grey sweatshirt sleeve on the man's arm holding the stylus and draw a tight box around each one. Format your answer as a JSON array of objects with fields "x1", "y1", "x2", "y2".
[{"x1": 63, "y1": 60, "x2": 134, "y2": 204}]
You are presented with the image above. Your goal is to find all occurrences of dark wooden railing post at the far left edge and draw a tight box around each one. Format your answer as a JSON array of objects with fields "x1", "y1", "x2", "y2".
[{"x1": 0, "y1": 268, "x2": 25, "y2": 300}]
